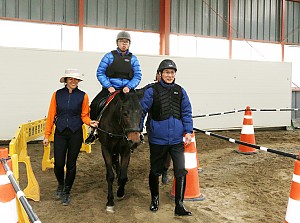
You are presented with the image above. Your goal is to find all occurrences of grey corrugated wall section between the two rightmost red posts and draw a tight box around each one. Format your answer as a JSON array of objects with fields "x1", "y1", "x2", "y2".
[{"x1": 233, "y1": 0, "x2": 281, "y2": 42}]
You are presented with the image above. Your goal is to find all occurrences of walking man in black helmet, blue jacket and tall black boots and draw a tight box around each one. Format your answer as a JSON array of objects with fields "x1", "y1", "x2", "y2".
[{"x1": 140, "y1": 59, "x2": 193, "y2": 216}]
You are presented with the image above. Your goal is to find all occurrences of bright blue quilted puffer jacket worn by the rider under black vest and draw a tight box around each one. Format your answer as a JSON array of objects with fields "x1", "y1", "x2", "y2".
[{"x1": 97, "y1": 48, "x2": 142, "y2": 89}]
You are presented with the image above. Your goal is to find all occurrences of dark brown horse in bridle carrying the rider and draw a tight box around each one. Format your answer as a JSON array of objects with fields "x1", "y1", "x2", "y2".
[{"x1": 97, "y1": 91, "x2": 143, "y2": 213}]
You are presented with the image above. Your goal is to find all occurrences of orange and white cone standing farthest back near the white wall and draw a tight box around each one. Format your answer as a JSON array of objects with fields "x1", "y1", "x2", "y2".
[{"x1": 238, "y1": 106, "x2": 256, "y2": 154}]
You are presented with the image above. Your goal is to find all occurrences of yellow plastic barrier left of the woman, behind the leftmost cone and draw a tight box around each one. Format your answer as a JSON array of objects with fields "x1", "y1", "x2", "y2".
[{"x1": 9, "y1": 119, "x2": 46, "y2": 201}]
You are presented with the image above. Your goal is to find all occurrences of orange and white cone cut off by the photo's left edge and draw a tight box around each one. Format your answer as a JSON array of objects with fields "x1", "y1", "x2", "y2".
[{"x1": 0, "y1": 148, "x2": 18, "y2": 223}]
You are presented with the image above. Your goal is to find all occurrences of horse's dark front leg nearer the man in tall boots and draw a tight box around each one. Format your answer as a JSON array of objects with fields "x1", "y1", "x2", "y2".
[{"x1": 117, "y1": 150, "x2": 130, "y2": 199}]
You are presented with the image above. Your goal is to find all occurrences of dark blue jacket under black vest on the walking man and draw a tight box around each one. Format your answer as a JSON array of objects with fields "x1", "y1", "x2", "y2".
[{"x1": 140, "y1": 81, "x2": 193, "y2": 145}]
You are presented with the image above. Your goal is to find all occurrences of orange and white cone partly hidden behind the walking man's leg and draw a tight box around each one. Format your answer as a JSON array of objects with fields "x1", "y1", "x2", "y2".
[{"x1": 171, "y1": 132, "x2": 204, "y2": 201}]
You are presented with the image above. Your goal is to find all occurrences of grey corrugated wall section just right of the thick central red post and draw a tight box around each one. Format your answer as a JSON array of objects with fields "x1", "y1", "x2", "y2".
[{"x1": 171, "y1": 0, "x2": 229, "y2": 37}]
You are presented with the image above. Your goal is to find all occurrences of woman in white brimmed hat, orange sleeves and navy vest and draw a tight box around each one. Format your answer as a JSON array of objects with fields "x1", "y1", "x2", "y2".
[{"x1": 43, "y1": 69, "x2": 98, "y2": 205}]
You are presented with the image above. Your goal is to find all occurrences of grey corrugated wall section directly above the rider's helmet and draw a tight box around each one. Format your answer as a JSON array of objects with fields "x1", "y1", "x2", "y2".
[{"x1": 85, "y1": 0, "x2": 160, "y2": 31}]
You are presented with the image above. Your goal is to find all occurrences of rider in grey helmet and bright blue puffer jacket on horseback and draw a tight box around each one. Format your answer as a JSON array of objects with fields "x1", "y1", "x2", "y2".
[{"x1": 85, "y1": 31, "x2": 142, "y2": 144}]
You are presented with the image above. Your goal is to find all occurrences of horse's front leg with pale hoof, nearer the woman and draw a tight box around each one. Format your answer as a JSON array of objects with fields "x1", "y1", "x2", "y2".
[{"x1": 102, "y1": 146, "x2": 115, "y2": 212}]
